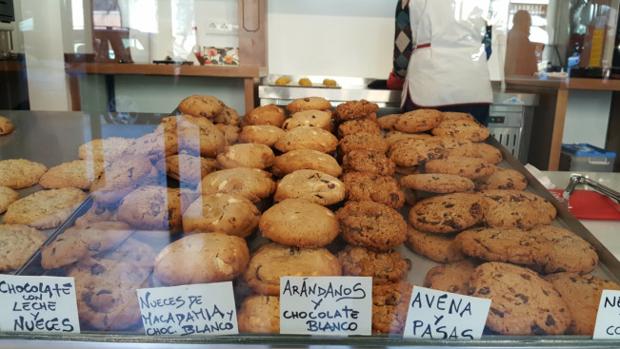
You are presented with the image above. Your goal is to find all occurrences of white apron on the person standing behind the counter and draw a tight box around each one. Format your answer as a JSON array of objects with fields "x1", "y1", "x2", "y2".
[{"x1": 402, "y1": 0, "x2": 493, "y2": 107}]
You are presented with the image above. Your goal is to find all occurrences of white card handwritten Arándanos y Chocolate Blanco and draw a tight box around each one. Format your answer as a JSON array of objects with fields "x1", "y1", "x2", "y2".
[{"x1": 280, "y1": 277, "x2": 372, "y2": 336}]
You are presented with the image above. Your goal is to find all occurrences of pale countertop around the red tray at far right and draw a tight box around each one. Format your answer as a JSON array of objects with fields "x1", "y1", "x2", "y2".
[{"x1": 543, "y1": 171, "x2": 620, "y2": 259}]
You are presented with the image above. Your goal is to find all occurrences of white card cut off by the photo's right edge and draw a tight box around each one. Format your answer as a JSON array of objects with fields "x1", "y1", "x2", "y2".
[{"x1": 593, "y1": 290, "x2": 620, "y2": 339}]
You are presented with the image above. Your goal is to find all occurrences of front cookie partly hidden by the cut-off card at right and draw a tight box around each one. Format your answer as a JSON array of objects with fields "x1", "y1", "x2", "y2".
[{"x1": 545, "y1": 273, "x2": 620, "y2": 336}]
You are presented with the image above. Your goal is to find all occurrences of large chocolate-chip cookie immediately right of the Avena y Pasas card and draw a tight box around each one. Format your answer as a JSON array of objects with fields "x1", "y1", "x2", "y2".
[{"x1": 469, "y1": 263, "x2": 571, "y2": 336}]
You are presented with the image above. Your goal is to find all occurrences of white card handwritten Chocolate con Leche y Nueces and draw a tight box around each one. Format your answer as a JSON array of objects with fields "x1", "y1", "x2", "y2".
[{"x1": 0, "y1": 275, "x2": 80, "y2": 333}]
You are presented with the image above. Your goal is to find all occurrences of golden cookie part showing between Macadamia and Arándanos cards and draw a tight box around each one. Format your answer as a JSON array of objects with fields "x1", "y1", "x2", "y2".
[{"x1": 237, "y1": 295, "x2": 280, "y2": 334}]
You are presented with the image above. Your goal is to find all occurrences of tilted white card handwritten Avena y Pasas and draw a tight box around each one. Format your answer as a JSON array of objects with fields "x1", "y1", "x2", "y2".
[{"x1": 404, "y1": 286, "x2": 491, "y2": 339}]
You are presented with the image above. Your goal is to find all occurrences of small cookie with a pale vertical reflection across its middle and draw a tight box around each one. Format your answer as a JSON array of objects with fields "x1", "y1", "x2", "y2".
[{"x1": 155, "y1": 154, "x2": 218, "y2": 185}]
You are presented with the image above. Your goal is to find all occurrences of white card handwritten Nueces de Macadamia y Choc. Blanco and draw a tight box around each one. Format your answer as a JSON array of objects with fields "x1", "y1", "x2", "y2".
[{"x1": 137, "y1": 281, "x2": 239, "y2": 336}]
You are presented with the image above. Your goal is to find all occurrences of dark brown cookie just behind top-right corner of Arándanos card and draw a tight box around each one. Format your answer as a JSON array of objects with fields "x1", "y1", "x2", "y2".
[{"x1": 338, "y1": 246, "x2": 411, "y2": 285}]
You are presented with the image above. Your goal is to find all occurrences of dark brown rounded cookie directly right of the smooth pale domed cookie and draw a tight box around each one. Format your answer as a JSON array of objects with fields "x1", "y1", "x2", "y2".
[{"x1": 336, "y1": 201, "x2": 407, "y2": 251}]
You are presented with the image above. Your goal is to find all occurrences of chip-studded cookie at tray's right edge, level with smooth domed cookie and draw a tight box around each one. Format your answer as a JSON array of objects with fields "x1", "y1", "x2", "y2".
[{"x1": 481, "y1": 190, "x2": 557, "y2": 229}]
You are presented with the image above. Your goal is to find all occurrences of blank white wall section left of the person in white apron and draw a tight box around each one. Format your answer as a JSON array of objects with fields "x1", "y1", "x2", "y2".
[{"x1": 267, "y1": 0, "x2": 396, "y2": 79}]
